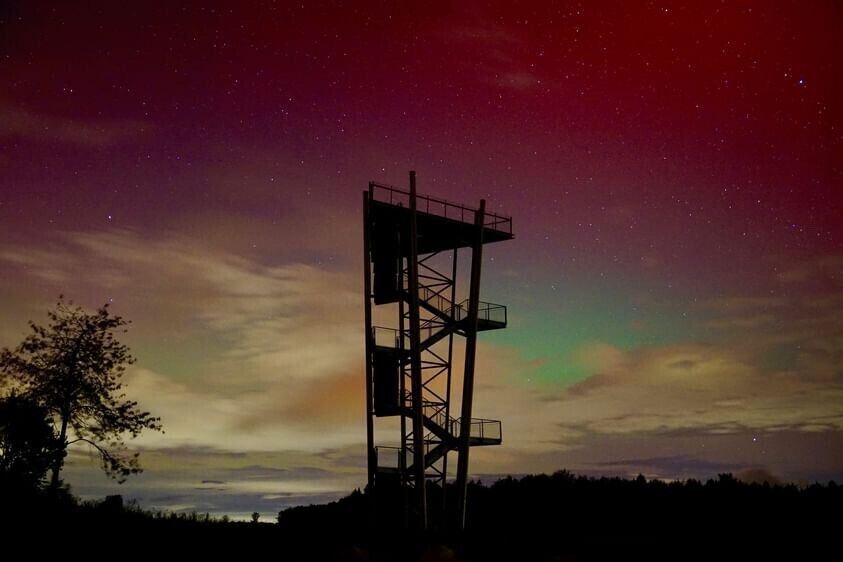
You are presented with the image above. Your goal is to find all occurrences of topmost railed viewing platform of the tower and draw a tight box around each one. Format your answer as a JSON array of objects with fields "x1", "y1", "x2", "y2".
[{"x1": 369, "y1": 182, "x2": 513, "y2": 261}]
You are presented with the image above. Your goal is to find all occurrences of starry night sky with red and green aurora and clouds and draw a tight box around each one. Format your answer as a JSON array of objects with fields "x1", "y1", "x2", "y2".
[{"x1": 0, "y1": 0, "x2": 843, "y2": 516}]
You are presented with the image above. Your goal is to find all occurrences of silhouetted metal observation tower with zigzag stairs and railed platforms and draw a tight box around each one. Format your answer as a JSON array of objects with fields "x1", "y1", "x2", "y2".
[{"x1": 363, "y1": 172, "x2": 512, "y2": 528}]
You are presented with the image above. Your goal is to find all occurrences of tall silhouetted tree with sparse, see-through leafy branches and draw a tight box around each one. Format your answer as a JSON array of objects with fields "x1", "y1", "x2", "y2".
[{"x1": 0, "y1": 296, "x2": 161, "y2": 490}]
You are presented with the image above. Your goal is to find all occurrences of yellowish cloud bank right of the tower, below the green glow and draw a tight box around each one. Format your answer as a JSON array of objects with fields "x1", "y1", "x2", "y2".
[{"x1": 550, "y1": 336, "x2": 843, "y2": 435}]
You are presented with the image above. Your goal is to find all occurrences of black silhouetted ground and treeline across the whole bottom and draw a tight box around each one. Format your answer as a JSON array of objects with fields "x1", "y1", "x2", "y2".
[{"x1": 0, "y1": 472, "x2": 843, "y2": 562}]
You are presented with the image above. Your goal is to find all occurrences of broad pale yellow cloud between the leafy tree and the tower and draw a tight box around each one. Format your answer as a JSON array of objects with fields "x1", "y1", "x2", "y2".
[{"x1": 0, "y1": 226, "x2": 363, "y2": 450}]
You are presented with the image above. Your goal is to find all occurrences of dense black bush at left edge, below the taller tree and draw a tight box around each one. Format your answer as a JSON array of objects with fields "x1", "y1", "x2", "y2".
[{"x1": 0, "y1": 394, "x2": 57, "y2": 490}]
